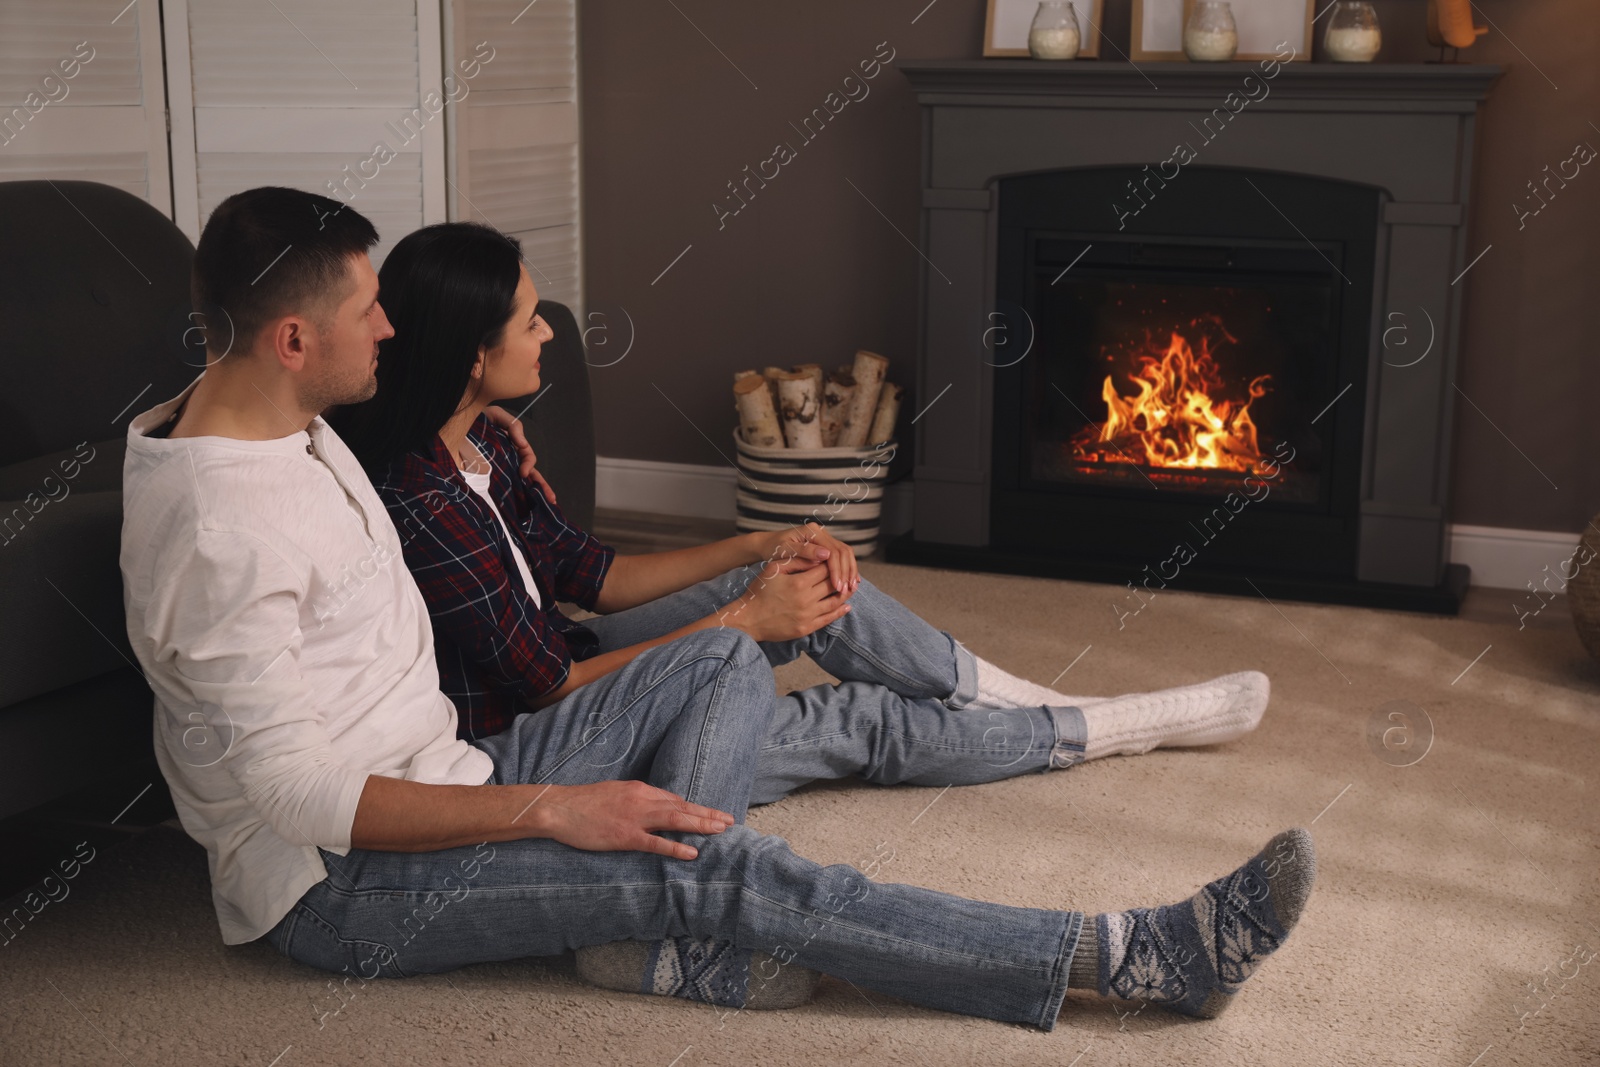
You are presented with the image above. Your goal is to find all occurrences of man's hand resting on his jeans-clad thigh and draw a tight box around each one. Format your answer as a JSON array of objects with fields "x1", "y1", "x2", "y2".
[{"x1": 523, "y1": 782, "x2": 733, "y2": 859}]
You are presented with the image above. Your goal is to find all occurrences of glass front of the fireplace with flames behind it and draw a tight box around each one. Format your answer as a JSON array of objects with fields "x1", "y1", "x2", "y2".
[{"x1": 1018, "y1": 242, "x2": 1339, "y2": 504}]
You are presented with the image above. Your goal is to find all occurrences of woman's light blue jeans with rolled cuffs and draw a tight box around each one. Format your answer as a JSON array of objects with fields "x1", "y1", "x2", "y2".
[{"x1": 584, "y1": 563, "x2": 1085, "y2": 805}]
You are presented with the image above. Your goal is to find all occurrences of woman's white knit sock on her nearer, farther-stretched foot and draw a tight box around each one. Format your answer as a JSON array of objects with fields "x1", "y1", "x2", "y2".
[{"x1": 1075, "y1": 670, "x2": 1272, "y2": 760}]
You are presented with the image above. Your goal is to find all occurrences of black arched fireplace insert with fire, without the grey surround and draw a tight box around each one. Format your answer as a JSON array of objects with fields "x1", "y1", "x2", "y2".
[{"x1": 989, "y1": 168, "x2": 1382, "y2": 576}]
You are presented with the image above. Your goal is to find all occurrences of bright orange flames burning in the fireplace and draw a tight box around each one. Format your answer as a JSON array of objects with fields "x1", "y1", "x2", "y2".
[{"x1": 1072, "y1": 331, "x2": 1272, "y2": 474}]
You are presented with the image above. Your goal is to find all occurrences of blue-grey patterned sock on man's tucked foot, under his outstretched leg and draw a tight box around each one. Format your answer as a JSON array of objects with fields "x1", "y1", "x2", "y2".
[{"x1": 578, "y1": 937, "x2": 822, "y2": 1009}]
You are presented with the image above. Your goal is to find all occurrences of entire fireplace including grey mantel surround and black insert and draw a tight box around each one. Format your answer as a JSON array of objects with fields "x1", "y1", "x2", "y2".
[{"x1": 885, "y1": 59, "x2": 1499, "y2": 613}]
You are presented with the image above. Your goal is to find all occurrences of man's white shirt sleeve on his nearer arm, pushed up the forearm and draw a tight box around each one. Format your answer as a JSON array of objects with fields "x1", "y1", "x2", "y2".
[{"x1": 146, "y1": 530, "x2": 368, "y2": 849}]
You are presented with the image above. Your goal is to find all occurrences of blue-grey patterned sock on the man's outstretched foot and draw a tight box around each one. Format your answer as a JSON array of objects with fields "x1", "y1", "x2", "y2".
[{"x1": 1067, "y1": 827, "x2": 1317, "y2": 1019}]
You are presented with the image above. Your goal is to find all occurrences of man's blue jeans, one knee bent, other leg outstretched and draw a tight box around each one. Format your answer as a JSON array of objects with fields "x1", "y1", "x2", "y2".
[{"x1": 267, "y1": 630, "x2": 1085, "y2": 1030}]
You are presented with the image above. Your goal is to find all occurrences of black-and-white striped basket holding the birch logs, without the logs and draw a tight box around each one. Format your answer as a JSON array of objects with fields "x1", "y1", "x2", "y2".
[{"x1": 733, "y1": 429, "x2": 894, "y2": 557}]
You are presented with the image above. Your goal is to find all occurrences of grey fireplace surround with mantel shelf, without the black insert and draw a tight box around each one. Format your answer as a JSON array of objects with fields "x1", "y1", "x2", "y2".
[{"x1": 890, "y1": 59, "x2": 1501, "y2": 607}]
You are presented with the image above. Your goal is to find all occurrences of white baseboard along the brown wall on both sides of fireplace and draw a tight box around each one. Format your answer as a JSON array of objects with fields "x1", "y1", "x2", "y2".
[{"x1": 595, "y1": 456, "x2": 1578, "y2": 589}]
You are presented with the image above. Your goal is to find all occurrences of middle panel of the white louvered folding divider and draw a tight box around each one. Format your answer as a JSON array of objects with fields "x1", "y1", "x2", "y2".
[{"x1": 165, "y1": 0, "x2": 445, "y2": 266}]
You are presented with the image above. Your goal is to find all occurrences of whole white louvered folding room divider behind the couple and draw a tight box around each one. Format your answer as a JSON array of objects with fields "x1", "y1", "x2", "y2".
[{"x1": 0, "y1": 0, "x2": 584, "y2": 295}]
